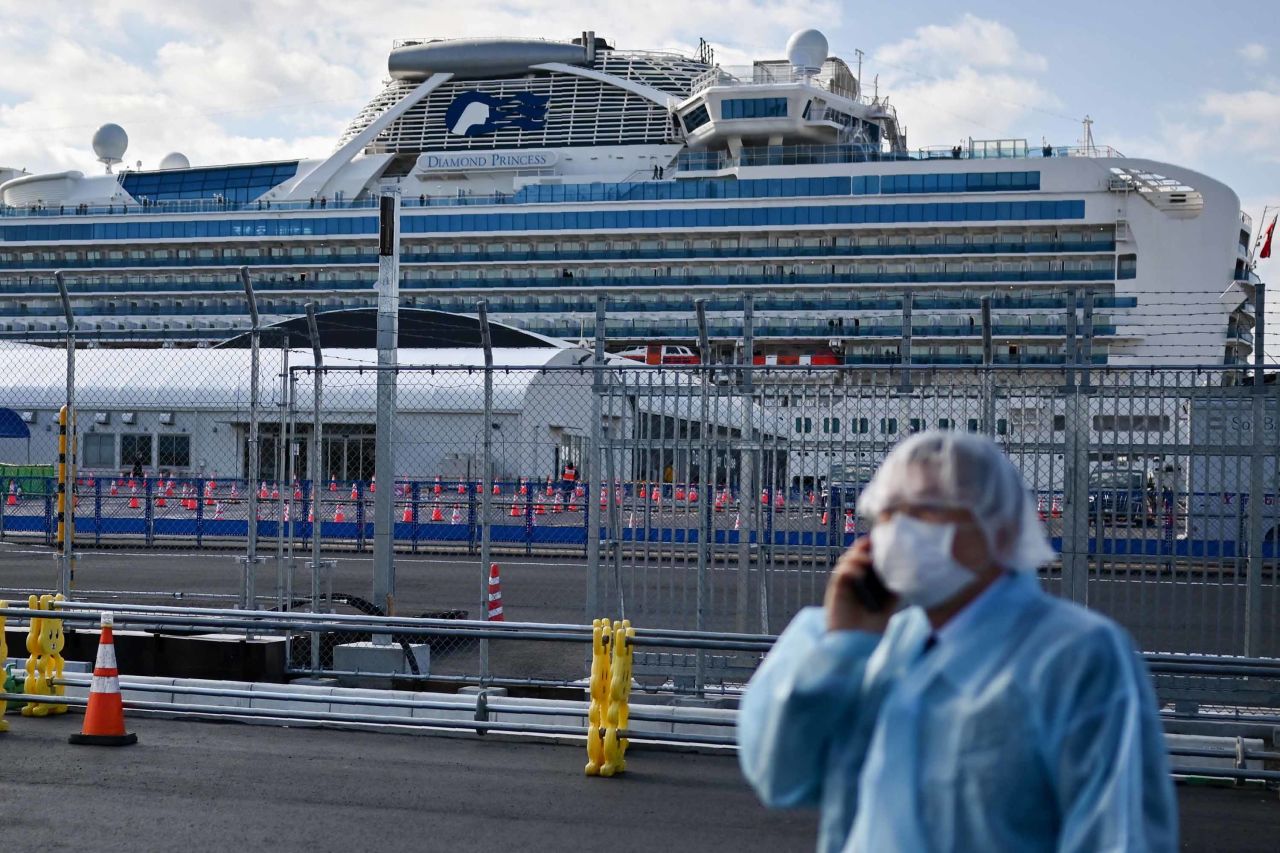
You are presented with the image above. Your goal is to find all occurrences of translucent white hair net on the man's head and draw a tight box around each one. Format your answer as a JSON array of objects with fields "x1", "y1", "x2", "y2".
[{"x1": 858, "y1": 430, "x2": 1055, "y2": 571}]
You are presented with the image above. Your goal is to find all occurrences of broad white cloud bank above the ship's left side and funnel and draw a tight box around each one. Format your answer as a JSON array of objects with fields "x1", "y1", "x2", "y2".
[{"x1": 0, "y1": 0, "x2": 844, "y2": 170}]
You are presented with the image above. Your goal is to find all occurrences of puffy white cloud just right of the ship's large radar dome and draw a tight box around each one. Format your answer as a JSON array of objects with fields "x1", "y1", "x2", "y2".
[{"x1": 864, "y1": 14, "x2": 1059, "y2": 147}]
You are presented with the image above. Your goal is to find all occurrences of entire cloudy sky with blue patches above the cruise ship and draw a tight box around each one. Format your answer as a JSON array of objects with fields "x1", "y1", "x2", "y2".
[{"x1": 0, "y1": 0, "x2": 1280, "y2": 350}]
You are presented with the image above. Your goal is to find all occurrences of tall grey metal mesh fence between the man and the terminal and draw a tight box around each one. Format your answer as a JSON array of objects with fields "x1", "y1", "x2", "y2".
[{"x1": 0, "y1": 322, "x2": 1280, "y2": 689}]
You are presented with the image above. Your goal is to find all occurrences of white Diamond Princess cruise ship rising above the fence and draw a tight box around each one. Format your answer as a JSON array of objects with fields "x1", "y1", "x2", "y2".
[{"x1": 0, "y1": 29, "x2": 1257, "y2": 369}]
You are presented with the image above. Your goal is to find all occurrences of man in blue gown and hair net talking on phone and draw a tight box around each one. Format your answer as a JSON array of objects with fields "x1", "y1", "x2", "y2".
[{"x1": 737, "y1": 432, "x2": 1178, "y2": 853}]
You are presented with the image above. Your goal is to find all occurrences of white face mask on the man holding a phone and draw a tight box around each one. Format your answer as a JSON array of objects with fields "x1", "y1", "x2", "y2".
[{"x1": 872, "y1": 512, "x2": 977, "y2": 610}]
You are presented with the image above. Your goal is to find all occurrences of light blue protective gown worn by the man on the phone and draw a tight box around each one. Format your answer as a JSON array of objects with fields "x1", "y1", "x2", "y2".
[{"x1": 737, "y1": 574, "x2": 1178, "y2": 853}]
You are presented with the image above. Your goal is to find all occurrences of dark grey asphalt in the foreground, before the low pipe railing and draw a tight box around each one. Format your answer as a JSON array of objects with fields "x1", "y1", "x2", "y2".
[{"x1": 0, "y1": 715, "x2": 1280, "y2": 853}]
